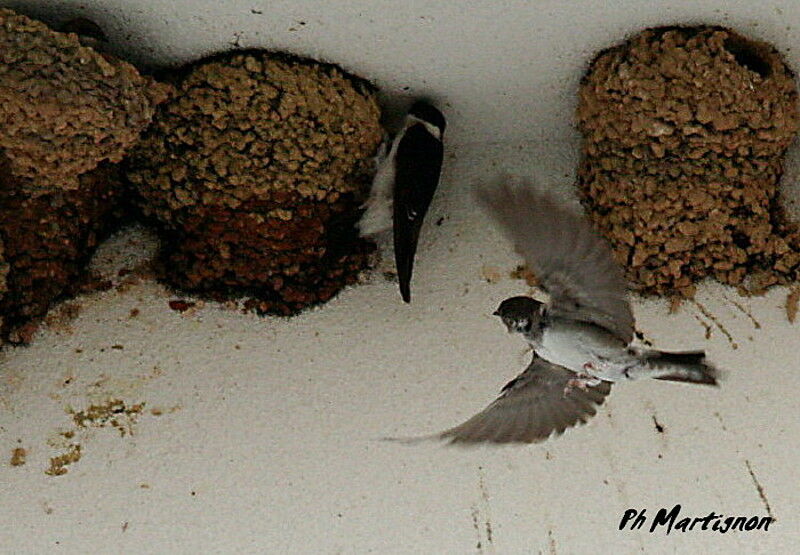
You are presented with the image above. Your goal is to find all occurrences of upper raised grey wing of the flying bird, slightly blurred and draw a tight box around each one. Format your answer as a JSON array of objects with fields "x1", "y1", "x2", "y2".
[{"x1": 478, "y1": 181, "x2": 634, "y2": 344}]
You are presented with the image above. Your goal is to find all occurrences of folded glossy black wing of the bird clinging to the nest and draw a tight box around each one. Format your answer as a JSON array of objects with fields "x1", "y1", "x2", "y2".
[{"x1": 392, "y1": 123, "x2": 444, "y2": 302}]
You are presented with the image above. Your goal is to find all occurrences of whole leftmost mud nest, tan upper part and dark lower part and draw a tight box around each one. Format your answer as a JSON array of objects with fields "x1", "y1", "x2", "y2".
[{"x1": 0, "y1": 9, "x2": 168, "y2": 342}]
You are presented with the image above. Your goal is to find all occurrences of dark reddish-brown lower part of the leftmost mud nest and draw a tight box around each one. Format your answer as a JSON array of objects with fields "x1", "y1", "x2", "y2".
[{"x1": 0, "y1": 157, "x2": 124, "y2": 343}]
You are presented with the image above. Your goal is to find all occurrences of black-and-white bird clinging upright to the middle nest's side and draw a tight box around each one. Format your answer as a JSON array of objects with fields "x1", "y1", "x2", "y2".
[{"x1": 359, "y1": 101, "x2": 446, "y2": 302}]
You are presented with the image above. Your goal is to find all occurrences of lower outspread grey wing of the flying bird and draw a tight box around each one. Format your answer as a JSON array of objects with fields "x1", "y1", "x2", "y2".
[{"x1": 437, "y1": 354, "x2": 611, "y2": 443}]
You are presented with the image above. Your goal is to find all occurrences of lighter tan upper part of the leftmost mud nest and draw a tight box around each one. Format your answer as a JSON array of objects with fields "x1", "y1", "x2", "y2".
[{"x1": 0, "y1": 9, "x2": 172, "y2": 190}]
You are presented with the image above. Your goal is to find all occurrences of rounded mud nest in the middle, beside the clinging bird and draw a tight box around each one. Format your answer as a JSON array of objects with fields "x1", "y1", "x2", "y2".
[{"x1": 128, "y1": 51, "x2": 382, "y2": 315}]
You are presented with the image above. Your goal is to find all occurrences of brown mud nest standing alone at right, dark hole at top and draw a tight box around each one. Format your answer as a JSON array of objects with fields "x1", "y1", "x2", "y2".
[{"x1": 577, "y1": 26, "x2": 800, "y2": 296}]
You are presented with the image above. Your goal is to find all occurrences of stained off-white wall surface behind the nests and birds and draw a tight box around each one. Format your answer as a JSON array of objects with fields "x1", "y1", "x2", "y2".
[{"x1": 0, "y1": 0, "x2": 800, "y2": 553}]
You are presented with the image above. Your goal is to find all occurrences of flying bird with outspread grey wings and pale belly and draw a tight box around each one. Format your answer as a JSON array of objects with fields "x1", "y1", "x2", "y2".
[{"x1": 405, "y1": 180, "x2": 717, "y2": 444}]
